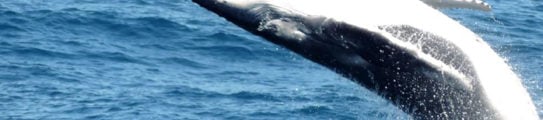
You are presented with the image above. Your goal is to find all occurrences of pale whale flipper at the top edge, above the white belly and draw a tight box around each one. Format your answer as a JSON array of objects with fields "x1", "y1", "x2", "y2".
[{"x1": 421, "y1": 0, "x2": 491, "y2": 11}]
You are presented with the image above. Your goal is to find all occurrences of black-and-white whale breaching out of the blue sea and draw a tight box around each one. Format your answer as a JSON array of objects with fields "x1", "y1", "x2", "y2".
[{"x1": 192, "y1": 0, "x2": 539, "y2": 120}]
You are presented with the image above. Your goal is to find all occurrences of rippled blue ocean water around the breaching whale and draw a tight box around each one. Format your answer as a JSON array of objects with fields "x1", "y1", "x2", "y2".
[{"x1": 0, "y1": 0, "x2": 543, "y2": 120}]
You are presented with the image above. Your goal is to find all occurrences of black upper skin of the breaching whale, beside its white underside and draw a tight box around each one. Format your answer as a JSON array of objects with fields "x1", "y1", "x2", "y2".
[{"x1": 193, "y1": 0, "x2": 500, "y2": 120}]
